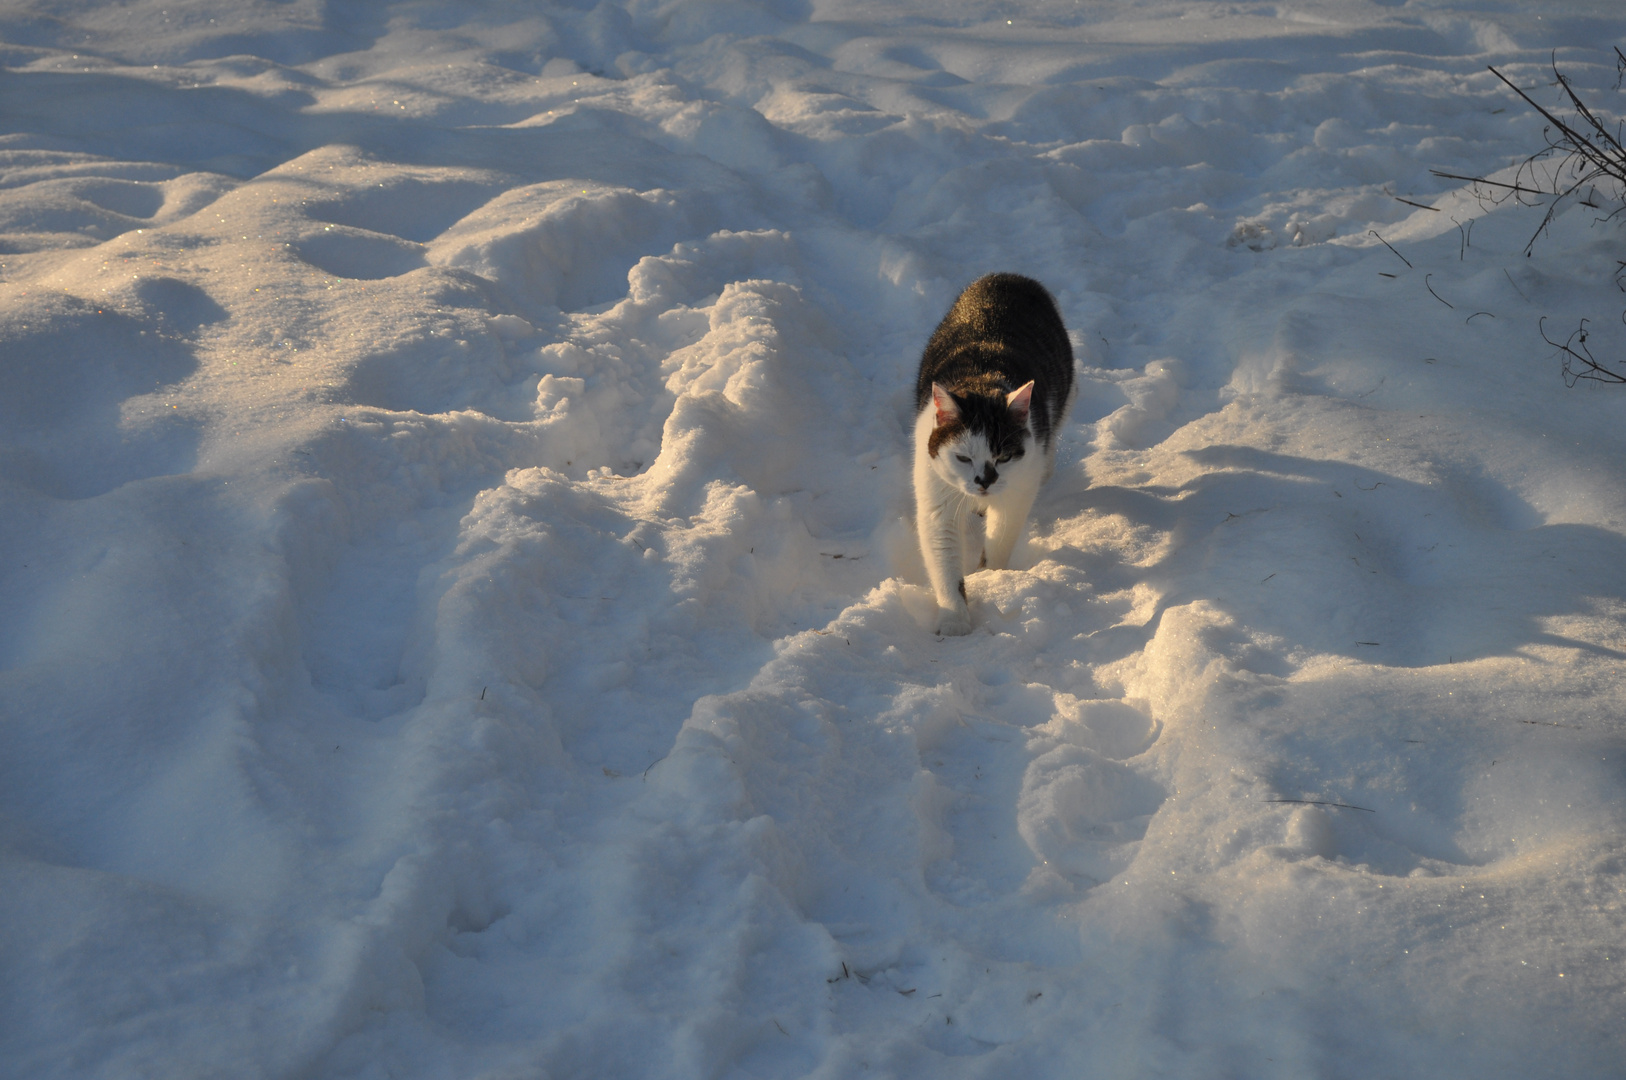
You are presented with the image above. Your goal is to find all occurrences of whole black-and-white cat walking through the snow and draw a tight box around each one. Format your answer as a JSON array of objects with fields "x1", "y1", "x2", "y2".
[{"x1": 914, "y1": 273, "x2": 1073, "y2": 636}]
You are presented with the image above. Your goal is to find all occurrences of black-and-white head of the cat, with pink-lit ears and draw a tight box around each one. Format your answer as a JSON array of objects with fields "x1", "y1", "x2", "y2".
[{"x1": 925, "y1": 382, "x2": 1033, "y2": 496}]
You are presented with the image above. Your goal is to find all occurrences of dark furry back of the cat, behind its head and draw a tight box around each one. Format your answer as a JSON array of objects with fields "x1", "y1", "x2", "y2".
[{"x1": 915, "y1": 273, "x2": 1073, "y2": 410}]
